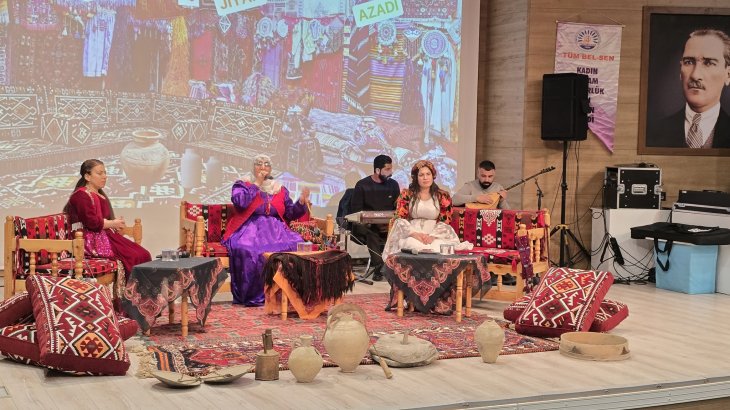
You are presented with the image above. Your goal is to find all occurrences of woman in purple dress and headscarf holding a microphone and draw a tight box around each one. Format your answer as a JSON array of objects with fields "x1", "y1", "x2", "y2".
[{"x1": 223, "y1": 155, "x2": 309, "y2": 306}]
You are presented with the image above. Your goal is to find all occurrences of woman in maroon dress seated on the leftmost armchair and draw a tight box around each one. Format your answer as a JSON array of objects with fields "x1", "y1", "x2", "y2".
[{"x1": 63, "y1": 159, "x2": 152, "y2": 278}]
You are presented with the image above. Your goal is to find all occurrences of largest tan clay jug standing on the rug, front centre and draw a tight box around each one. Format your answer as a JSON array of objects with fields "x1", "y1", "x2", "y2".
[{"x1": 324, "y1": 303, "x2": 370, "y2": 373}]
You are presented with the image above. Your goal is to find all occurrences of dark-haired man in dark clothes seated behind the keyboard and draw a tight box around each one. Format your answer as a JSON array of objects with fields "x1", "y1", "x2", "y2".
[{"x1": 348, "y1": 155, "x2": 400, "y2": 280}]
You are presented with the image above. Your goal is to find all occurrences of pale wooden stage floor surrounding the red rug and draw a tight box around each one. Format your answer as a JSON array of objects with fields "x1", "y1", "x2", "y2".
[{"x1": 0, "y1": 282, "x2": 730, "y2": 409}]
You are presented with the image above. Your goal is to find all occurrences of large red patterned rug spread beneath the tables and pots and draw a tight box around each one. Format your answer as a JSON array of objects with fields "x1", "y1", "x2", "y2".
[{"x1": 140, "y1": 294, "x2": 558, "y2": 375}]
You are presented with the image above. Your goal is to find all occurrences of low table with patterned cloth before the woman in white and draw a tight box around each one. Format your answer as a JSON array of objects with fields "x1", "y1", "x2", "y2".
[{"x1": 383, "y1": 253, "x2": 491, "y2": 322}]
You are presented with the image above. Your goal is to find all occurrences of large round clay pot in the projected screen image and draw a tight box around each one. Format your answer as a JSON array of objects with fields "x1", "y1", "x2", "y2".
[{"x1": 120, "y1": 130, "x2": 170, "y2": 186}]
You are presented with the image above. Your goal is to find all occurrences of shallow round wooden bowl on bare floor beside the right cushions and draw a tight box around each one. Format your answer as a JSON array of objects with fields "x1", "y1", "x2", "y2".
[{"x1": 560, "y1": 332, "x2": 631, "y2": 361}]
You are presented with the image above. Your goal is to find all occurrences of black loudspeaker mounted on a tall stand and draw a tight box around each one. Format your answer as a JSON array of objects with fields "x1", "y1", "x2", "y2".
[{"x1": 541, "y1": 73, "x2": 590, "y2": 141}]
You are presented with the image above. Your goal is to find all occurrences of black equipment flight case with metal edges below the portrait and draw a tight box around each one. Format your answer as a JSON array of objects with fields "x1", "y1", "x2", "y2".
[{"x1": 603, "y1": 164, "x2": 662, "y2": 209}]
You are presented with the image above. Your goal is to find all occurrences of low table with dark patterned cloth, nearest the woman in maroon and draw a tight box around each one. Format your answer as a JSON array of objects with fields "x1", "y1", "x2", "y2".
[{"x1": 122, "y1": 258, "x2": 228, "y2": 337}]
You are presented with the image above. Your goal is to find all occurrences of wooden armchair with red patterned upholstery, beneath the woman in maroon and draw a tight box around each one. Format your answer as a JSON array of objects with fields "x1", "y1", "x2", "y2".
[{"x1": 4, "y1": 213, "x2": 142, "y2": 299}]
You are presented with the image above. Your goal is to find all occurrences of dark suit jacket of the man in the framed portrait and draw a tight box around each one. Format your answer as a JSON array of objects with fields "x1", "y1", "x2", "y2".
[{"x1": 646, "y1": 108, "x2": 730, "y2": 148}]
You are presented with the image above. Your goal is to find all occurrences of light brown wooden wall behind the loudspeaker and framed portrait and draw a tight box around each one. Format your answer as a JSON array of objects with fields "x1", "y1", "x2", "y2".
[{"x1": 476, "y1": 0, "x2": 730, "y2": 259}]
